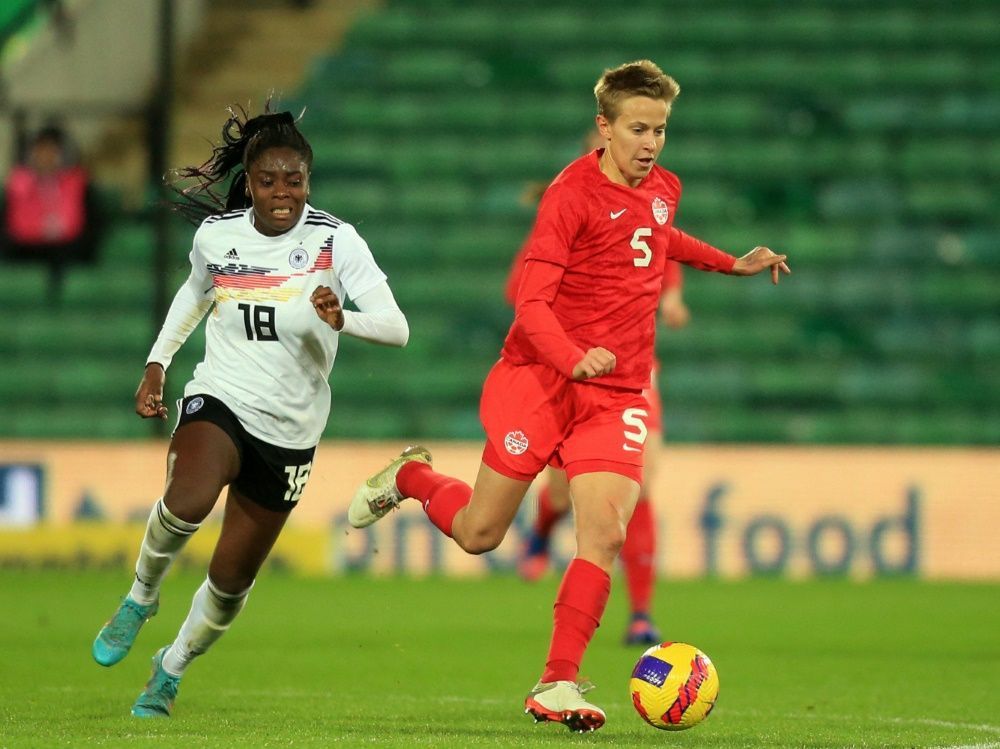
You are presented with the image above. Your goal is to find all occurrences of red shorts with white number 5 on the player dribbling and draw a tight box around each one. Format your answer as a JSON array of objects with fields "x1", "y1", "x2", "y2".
[{"x1": 479, "y1": 359, "x2": 649, "y2": 483}]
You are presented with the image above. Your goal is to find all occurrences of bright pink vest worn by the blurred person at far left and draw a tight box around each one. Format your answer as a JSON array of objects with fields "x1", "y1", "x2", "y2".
[{"x1": 6, "y1": 165, "x2": 87, "y2": 244}]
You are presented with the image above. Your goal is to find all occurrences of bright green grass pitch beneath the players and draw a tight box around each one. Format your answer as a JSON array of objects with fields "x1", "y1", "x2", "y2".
[{"x1": 0, "y1": 571, "x2": 1000, "y2": 749}]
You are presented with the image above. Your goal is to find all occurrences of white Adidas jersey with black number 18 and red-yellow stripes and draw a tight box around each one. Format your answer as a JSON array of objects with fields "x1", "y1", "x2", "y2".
[{"x1": 147, "y1": 205, "x2": 386, "y2": 448}]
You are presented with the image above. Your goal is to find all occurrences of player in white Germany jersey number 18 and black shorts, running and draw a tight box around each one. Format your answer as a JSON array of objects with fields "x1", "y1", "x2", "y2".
[{"x1": 93, "y1": 102, "x2": 409, "y2": 717}]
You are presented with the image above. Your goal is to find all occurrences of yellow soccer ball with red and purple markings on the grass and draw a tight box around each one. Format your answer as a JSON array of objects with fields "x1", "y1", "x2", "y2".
[{"x1": 629, "y1": 642, "x2": 719, "y2": 731}]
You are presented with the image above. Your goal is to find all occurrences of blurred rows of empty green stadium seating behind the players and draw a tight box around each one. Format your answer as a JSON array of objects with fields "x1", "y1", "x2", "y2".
[{"x1": 0, "y1": 0, "x2": 1000, "y2": 444}]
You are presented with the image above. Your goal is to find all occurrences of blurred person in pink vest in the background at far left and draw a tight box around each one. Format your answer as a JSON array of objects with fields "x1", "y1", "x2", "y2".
[{"x1": 3, "y1": 125, "x2": 97, "y2": 300}]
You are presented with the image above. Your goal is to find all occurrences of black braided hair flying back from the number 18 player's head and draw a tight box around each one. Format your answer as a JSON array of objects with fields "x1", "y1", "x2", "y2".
[{"x1": 166, "y1": 99, "x2": 312, "y2": 225}]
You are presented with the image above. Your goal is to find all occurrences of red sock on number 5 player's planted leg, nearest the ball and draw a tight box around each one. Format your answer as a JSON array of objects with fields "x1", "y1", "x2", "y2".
[{"x1": 542, "y1": 558, "x2": 611, "y2": 682}]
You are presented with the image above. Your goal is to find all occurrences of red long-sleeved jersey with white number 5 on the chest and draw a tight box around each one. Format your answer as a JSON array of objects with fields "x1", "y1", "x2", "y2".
[{"x1": 501, "y1": 149, "x2": 736, "y2": 390}]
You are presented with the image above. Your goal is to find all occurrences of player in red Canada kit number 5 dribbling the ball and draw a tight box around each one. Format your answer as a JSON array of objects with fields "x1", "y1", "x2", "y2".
[{"x1": 348, "y1": 60, "x2": 789, "y2": 731}]
